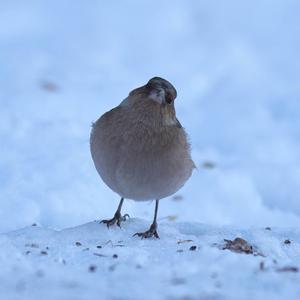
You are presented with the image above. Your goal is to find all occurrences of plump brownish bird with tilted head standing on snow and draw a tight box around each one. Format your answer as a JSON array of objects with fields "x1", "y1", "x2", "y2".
[{"x1": 90, "y1": 77, "x2": 195, "y2": 238}]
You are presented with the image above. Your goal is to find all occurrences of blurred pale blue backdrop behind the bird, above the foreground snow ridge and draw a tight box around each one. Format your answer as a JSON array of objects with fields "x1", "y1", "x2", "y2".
[{"x1": 0, "y1": 0, "x2": 300, "y2": 232}]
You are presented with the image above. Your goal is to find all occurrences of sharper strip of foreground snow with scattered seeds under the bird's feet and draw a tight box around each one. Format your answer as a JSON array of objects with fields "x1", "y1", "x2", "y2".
[{"x1": 0, "y1": 219, "x2": 300, "y2": 299}]
